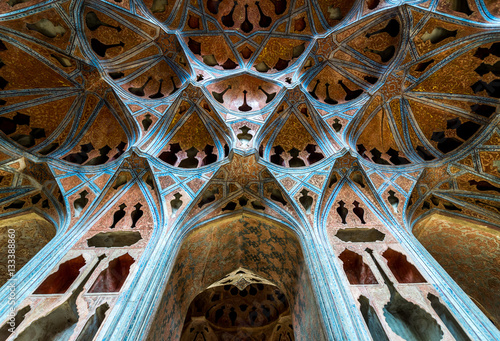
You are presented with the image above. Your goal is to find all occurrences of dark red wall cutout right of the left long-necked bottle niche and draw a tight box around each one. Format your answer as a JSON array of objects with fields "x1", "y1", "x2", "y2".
[{"x1": 89, "y1": 253, "x2": 135, "y2": 293}]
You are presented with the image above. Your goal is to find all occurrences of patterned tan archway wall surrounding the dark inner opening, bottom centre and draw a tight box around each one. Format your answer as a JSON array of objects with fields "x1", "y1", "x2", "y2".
[{"x1": 147, "y1": 213, "x2": 324, "y2": 340}]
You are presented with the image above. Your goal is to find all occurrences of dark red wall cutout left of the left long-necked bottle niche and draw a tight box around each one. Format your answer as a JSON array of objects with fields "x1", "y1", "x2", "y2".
[{"x1": 33, "y1": 255, "x2": 85, "y2": 295}]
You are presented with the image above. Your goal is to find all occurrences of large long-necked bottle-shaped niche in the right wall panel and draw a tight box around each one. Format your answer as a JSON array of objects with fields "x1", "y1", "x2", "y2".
[{"x1": 365, "y1": 248, "x2": 443, "y2": 341}]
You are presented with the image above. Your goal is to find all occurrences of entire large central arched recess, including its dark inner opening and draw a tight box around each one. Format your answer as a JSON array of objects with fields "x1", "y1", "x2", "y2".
[{"x1": 147, "y1": 213, "x2": 325, "y2": 341}]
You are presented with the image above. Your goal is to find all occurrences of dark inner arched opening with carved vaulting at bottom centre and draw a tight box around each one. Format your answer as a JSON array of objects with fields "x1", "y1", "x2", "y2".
[{"x1": 181, "y1": 268, "x2": 295, "y2": 341}]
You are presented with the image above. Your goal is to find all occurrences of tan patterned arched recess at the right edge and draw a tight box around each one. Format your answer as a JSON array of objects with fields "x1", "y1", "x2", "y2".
[{"x1": 413, "y1": 213, "x2": 500, "y2": 327}]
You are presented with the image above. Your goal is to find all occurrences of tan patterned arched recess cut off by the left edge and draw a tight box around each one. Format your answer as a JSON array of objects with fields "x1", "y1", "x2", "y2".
[{"x1": 0, "y1": 212, "x2": 56, "y2": 286}]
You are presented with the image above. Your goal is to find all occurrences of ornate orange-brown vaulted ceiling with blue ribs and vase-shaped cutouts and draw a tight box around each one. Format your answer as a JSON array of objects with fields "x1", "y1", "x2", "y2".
[{"x1": 0, "y1": 0, "x2": 500, "y2": 168}]
